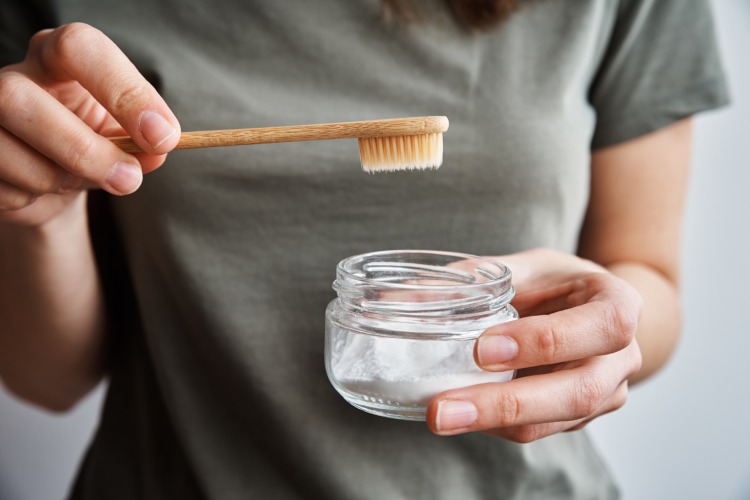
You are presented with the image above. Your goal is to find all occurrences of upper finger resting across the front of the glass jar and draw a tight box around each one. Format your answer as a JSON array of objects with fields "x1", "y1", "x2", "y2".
[{"x1": 475, "y1": 273, "x2": 640, "y2": 371}]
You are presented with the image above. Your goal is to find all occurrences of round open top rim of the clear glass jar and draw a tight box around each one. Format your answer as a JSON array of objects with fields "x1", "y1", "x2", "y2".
[{"x1": 336, "y1": 250, "x2": 512, "y2": 291}]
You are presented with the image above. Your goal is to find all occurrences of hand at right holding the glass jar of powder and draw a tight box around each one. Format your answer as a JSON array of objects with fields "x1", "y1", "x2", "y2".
[{"x1": 427, "y1": 250, "x2": 642, "y2": 443}]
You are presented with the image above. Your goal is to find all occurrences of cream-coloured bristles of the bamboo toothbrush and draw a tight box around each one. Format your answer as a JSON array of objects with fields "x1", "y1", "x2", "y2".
[{"x1": 359, "y1": 132, "x2": 443, "y2": 172}]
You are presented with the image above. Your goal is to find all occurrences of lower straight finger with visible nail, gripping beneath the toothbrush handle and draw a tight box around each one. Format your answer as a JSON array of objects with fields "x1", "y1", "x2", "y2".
[{"x1": 0, "y1": 72, "x2": 142, "y2": 194}]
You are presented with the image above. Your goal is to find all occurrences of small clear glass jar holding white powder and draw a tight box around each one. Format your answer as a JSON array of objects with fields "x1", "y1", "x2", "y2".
[{"x1": 325, "y1": 250, "x2": 518, "y2": 420}]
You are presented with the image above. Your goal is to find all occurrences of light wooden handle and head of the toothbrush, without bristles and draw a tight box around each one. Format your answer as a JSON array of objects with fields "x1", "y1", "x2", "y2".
[{"x1": 110, "y1": 116, "x2": 448, "y2": 153}]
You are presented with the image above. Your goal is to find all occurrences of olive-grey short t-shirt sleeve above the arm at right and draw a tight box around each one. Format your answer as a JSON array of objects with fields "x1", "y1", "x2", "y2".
[{"x1": 589, "y1": 0, "x2": 729, "y2": 149}]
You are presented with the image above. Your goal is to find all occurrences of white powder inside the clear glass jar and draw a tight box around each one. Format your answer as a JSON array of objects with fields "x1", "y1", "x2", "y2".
[{"x1": 331, "y1": 327, "x2": 513, "y2": 406}]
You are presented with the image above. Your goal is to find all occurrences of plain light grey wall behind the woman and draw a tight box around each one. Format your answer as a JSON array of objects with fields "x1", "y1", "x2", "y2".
[{"x1": 0, "y1": 0, "x2": 750, "y2": 500}]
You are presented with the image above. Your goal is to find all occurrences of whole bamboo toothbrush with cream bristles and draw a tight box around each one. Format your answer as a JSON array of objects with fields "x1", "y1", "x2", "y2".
[{"x1": 111, "y1": 116, "x2": 448, "y2": 172}]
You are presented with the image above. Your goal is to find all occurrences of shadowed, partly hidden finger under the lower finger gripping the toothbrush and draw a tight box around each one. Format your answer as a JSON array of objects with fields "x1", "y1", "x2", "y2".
[{"x1": 0, "y1": 129, "x2": 83, "y2": 195}]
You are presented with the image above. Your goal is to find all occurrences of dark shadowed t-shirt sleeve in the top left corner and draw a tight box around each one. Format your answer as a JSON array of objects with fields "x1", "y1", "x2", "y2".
[{"x1": 0, "y1": 0, "x2": 52, "y2": 68}]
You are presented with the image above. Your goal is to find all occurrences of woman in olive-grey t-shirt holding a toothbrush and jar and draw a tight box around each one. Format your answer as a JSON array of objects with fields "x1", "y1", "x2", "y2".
[{"x1": 0, "y1": 0, "x2": 726, "y2": 499}]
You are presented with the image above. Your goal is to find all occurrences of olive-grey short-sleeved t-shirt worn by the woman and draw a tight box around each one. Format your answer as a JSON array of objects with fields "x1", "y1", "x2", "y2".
[{"x1": 0, "y1": 0, "x2": 726, "y2": 500}]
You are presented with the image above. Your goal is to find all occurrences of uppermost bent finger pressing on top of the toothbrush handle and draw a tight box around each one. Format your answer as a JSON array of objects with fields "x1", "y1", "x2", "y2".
[{"x1": 29, "y1": 23, "x2": 180, "y2": 154}]
